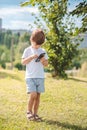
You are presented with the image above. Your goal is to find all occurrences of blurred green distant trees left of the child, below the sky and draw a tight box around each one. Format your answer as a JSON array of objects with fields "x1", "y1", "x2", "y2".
[{"x1": 0, "y1": 30, "x2": 30, "y2": 68}]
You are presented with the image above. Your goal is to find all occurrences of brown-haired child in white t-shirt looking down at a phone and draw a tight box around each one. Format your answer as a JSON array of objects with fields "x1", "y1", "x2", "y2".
[{"x1": 22, "y1": 29, "x2": 48, "y2": 121}]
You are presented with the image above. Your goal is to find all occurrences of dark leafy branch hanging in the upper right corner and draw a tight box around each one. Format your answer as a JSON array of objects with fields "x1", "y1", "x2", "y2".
[{"x1": 71, "y1": 0, "x2": 87, "y2": 32}]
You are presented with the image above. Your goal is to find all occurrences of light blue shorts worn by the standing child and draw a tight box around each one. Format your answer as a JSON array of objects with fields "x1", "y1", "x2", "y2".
[{"x1": 26, "y1": 78, "x2": 45, "y2": 93}]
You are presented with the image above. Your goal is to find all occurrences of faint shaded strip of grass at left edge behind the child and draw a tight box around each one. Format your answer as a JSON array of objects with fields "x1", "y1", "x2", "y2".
[{"x1": 0, "y1": 72, "x2": 21, "y2": 81}]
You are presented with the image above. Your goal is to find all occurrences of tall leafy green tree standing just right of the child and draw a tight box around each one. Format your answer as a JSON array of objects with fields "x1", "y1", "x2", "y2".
[{"x1": 22, "y1": 0, "x2": 78, "y2": 77}]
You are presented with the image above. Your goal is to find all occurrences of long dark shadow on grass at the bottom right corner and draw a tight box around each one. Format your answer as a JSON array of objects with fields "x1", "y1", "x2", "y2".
[{"x1": 44, "y1": 120, "x2": 87, "y2": 130}]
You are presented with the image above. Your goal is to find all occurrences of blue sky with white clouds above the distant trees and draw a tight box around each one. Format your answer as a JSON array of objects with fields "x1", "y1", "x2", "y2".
[{"x1": 0, "y1": 0, "x2": 82, "y2": 30}]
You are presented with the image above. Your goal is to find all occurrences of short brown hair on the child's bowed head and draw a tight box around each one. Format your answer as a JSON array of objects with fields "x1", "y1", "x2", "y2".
[{"x1": 30, "y1": 29, "x2": 45, "y2": 45}]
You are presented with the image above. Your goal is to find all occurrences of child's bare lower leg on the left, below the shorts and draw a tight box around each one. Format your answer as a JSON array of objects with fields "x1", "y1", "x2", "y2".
[{"x1": 28, "y1": 92, "x2": 37, "y2": 113}]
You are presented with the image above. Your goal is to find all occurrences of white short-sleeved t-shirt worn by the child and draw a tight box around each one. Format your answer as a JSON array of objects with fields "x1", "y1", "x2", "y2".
[{"x1": 22, "y1": 46, "x2": 48, "y2": 78}]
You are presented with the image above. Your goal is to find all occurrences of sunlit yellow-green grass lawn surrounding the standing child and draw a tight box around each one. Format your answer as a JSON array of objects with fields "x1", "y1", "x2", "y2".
[{"x1": 0, "y1": 70, "x2": 87, "y2": 130}]
